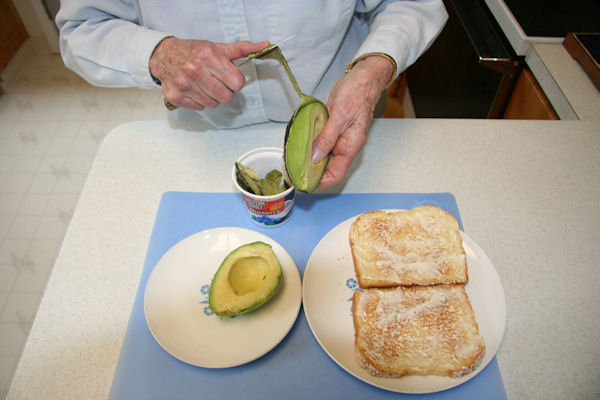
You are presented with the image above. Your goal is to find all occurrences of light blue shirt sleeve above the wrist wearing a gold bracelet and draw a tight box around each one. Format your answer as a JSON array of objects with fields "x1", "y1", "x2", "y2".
[{"x1": 354, "y1": 0, "x2": 448, "y2": 81}]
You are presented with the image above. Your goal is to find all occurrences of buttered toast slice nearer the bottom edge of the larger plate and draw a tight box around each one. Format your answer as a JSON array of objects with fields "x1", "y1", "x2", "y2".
[{"x1": 353, "y1": 285, "x2": 485, "y2": 377}]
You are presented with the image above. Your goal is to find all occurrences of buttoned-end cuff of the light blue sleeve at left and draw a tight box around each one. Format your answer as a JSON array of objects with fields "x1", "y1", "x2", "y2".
[{"x1": 127, "y1": 28, "x2": 173, "y2": 89}]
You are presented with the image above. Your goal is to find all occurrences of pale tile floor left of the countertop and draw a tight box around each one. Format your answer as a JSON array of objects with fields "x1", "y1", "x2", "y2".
[{"x1": 0, "y1": 47, "x2": 166, "y2": 399}]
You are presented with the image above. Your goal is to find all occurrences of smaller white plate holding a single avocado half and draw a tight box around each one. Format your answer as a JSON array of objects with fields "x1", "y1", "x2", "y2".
[{"x1": 144, "y1": 227, "x2": 302, "y2": 368}]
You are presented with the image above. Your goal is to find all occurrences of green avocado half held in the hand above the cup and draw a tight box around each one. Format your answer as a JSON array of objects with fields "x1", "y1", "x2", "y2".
[{"x1": 284, "y1": 99, "x2": 329, "y2": 193}]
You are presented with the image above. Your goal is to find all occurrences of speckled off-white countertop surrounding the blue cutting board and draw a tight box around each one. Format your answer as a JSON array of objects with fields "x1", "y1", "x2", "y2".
[{"x1": 8, "y1": 119, "x2": 600, "y2": 400}]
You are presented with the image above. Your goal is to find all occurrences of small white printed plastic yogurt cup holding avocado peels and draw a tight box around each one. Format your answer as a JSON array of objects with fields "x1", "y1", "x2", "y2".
[{"x1": 231, "y1": 147, "x2": 296, "y2": 228}]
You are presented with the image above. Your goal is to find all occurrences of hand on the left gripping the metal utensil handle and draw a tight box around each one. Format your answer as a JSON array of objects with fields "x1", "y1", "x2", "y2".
[{"x1": 149, "y1": 37, "x2": 268, "y2": 111}]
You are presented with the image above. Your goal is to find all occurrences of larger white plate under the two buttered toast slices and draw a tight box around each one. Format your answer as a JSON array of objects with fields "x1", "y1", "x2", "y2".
[{"x1": 303, "y1": 210, "x2": 506, "y2": 393}]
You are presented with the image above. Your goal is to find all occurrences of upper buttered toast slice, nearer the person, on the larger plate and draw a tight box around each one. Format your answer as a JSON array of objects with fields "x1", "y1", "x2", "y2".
[{"x1": 350, "y1": 205, "x2": 468, "y2": 288}]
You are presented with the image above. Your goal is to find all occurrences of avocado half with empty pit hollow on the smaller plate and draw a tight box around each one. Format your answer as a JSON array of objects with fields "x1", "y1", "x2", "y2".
[{"x1": 208, "y1": 242, "x2": 282, "y2": 317}]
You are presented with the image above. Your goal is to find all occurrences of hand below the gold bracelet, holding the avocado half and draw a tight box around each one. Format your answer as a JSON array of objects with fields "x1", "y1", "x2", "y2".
[{"x1": 313, "y1": 56, "x2": 394, "y2": 188}]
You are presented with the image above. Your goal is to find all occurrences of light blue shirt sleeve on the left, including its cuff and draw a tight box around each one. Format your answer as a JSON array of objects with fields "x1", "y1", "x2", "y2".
[{"x1": 56, "y1": 0, "x2": 170, "y2": 88}]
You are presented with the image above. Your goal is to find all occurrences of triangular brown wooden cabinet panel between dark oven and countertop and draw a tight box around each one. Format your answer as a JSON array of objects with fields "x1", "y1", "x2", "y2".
[{"x1": 504, "y1": 68, "x2": 558, "y2": 120}]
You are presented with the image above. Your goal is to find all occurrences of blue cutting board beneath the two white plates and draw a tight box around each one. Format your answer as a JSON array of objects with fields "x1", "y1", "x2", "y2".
[{"x1": 110, "y1": 192, "x2": 506, "y2": 400}]
